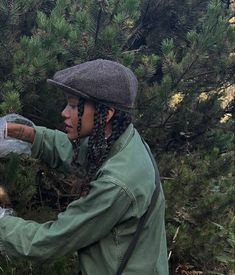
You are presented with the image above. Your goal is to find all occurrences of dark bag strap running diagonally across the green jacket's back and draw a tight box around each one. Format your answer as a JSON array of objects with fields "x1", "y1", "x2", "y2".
[{"x1": 116, "y1": 139, "x2": 160, "y2": 275}]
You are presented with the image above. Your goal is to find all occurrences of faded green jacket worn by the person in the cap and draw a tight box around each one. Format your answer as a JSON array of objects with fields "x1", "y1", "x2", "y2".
[{"x1": 0, "y1": 124, "x2": 168, "y2": 275}]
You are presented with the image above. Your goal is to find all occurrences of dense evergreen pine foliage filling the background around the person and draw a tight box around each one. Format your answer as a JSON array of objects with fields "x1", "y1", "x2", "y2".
[{"x1": 0, "y1": 0, "x2": 234, "y2": 274}]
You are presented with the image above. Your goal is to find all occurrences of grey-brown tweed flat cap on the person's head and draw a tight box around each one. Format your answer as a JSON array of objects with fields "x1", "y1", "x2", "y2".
[{"x1": 47, "y1": 59, "x2": 138, "y2": 111}]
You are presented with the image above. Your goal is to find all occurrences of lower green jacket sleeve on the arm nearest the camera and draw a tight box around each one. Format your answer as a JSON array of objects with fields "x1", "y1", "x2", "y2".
[{"x1": 0, "y1": 180, "x2": 132, "y2": 261}]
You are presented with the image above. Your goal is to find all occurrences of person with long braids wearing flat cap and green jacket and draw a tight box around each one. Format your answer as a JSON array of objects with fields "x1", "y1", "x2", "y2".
[{"x1": 0, "y1": 59, "x2": 168, "y2": 275}]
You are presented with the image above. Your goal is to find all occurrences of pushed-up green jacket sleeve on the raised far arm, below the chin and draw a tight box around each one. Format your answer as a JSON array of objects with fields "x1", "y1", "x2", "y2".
[{"x1": 32, "y1": 127, "x2": 73, "y2": 171}]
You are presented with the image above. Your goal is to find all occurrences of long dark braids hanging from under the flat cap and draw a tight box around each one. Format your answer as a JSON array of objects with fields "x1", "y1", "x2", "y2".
[{"x1": 72, "y1": 99, "x2": 132, "y2": 196}]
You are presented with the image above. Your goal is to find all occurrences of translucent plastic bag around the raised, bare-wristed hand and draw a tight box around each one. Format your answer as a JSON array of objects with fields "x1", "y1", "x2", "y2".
[{"x1": 0, "y1": 114, "x2": 34, "y2": 158}]
